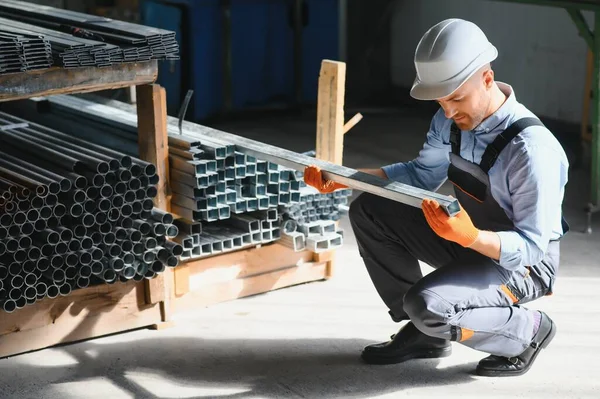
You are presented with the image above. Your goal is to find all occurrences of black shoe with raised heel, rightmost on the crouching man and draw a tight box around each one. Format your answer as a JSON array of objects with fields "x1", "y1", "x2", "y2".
[{"x1": 476, "y1": 312, "x2": 556, "y2": 377}]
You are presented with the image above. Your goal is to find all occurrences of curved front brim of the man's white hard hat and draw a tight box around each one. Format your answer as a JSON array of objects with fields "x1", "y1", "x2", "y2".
[{"x1": 410, "y1": 44, "x2": 498, "y2": 101}]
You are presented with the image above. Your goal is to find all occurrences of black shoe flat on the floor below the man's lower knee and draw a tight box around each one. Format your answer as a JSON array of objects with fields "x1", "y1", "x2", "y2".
[{"x1": 361, "y1": 322, "x2": 452, "y2": 364}]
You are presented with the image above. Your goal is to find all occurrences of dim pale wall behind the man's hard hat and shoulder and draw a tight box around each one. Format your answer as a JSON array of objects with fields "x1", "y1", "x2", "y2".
[{"x1": 391, "y1": 0, "x2": 593, "y2": 123}]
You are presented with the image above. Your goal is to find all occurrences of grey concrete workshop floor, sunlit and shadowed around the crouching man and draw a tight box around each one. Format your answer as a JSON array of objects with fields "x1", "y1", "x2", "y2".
[{"x1": 0, "y1": 110, "x2": 600, "y2": 399}]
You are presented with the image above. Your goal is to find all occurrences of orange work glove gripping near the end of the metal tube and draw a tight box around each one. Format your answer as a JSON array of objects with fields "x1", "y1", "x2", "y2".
[{"x1": 422, "y1": 199, "x2": 479, "y2": 247}]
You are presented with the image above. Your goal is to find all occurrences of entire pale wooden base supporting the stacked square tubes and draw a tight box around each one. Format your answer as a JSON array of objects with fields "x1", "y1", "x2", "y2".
[{"x1": 171, "y1": 243, "x2": 333, "y2": 313}]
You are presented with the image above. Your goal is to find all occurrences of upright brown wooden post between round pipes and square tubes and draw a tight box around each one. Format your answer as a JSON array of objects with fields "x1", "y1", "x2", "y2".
[{"x1": 136, "y1": 84, "x2": 172, "y2": 327}]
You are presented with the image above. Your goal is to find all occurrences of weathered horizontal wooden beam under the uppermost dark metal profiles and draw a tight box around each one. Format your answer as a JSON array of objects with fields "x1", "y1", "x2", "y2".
[{"x1": 0, "y1": 60, "x2": 158, "y2": 101}]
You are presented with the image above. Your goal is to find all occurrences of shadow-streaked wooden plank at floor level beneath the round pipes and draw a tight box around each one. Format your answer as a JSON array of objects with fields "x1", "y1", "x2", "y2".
[{"x1": 0, "y1": 281, "x2": 161, "y2": 357}]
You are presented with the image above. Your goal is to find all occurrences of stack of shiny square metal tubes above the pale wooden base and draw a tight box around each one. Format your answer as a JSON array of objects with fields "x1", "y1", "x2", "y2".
[{"x1": 0, "y1": 96, "x2": 351, "y2": 259}]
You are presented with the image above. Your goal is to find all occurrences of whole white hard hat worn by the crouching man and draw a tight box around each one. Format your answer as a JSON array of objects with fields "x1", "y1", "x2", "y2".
[{"x1": 410, "y1": 19, "x2": 498, "y2": 100}]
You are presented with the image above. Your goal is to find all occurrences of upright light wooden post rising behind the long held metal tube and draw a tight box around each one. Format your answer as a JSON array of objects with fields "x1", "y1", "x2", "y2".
[{"x1": 316, "y1": 60, "x2": 346, "y2": 165}]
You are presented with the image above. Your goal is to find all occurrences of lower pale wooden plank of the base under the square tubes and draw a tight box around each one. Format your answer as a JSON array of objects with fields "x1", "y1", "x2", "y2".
[{"x1": 174, "y1": 263, "x2": 326, "y2": 312}]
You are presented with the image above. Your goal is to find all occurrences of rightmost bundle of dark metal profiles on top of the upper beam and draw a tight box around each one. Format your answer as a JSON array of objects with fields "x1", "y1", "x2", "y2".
[{"x1": 0, "y1": 0, "x2": 179, "y2": 63}]
